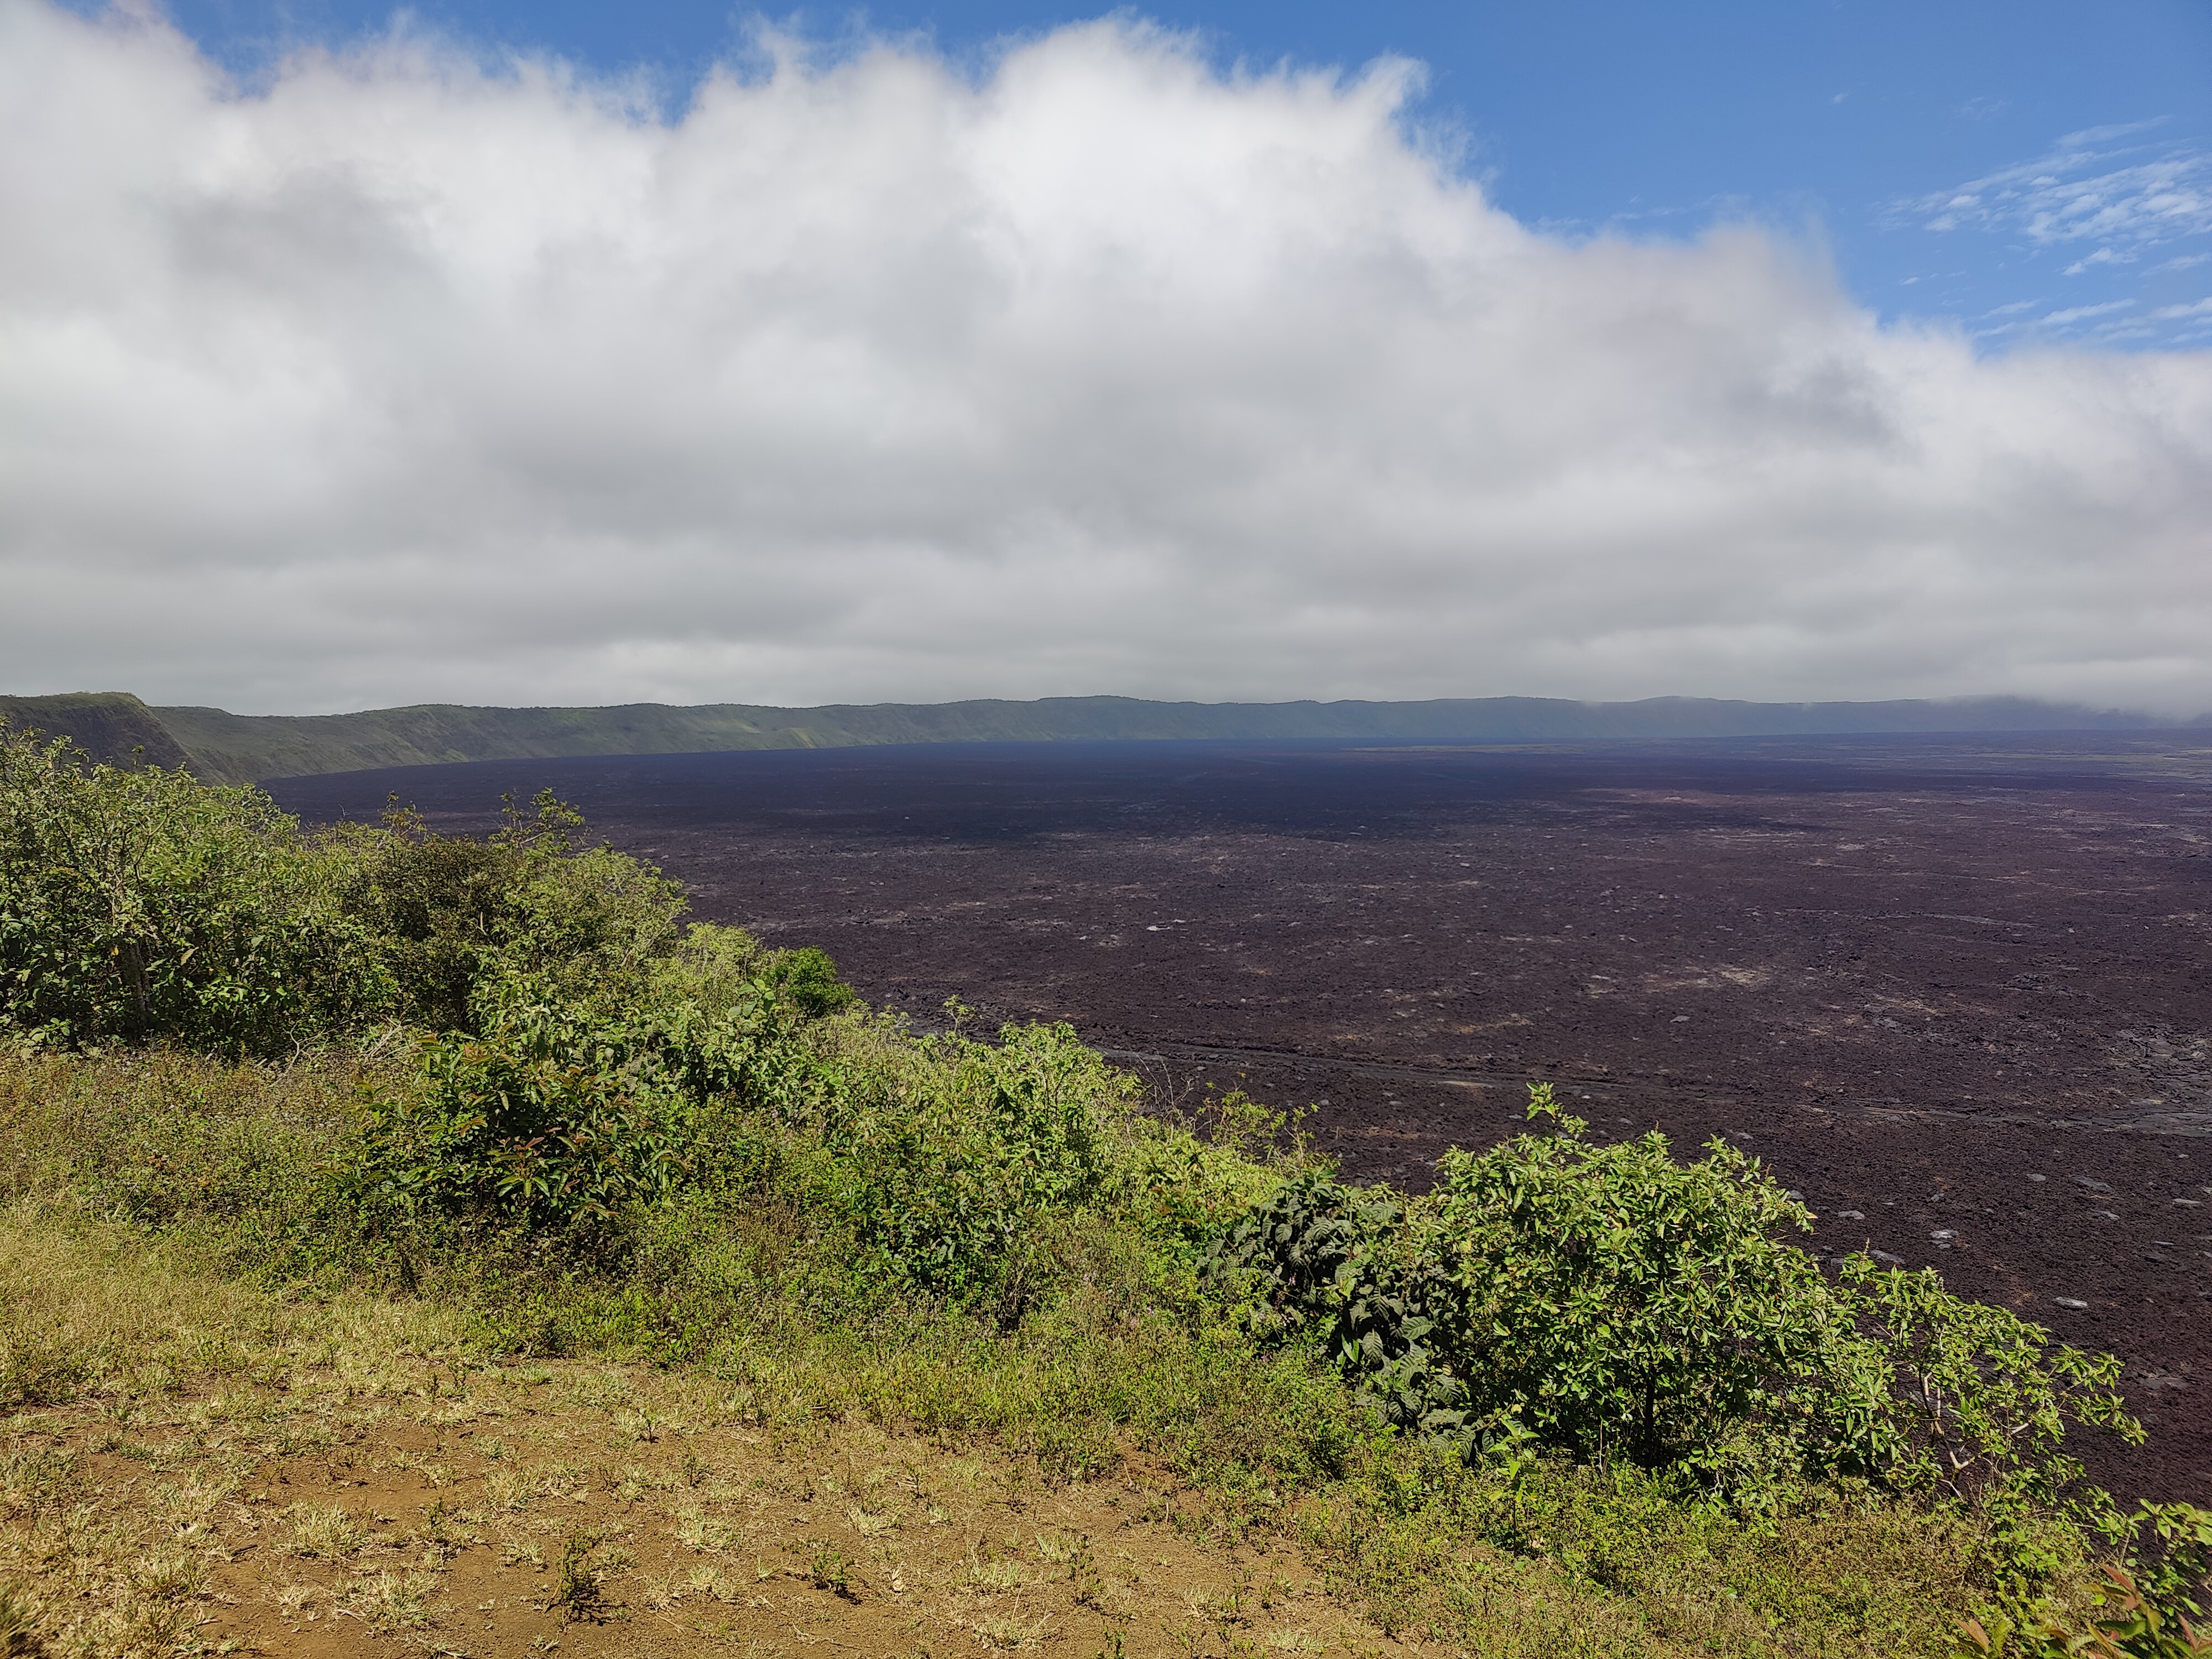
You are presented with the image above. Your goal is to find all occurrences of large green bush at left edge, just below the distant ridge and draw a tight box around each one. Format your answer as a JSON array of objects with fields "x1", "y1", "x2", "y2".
[{"x1": 0, "y1": 728, "x2": 389, "y2": 1055}]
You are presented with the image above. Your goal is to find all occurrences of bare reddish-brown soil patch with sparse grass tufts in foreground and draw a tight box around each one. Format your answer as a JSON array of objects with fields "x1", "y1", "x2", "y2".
[{"x1": 0, "y1": 1365, "x2": 1396, "y2": 1659}]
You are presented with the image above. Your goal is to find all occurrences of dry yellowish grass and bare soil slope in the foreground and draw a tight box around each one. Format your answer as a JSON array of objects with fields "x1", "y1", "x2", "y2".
[{"x1": 0, "y1": 1210, "x2": 2035, "y2": 1659}]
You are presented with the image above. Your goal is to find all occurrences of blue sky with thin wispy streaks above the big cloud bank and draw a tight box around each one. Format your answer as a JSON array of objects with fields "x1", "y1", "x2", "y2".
[{"x1": 147, "y1": 0, "x2": 2212, "y2": 349}]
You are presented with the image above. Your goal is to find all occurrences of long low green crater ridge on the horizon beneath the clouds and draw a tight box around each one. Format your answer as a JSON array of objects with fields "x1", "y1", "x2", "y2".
[{"x1": 0, "y1": 692, "x2": 2205, "y2": 783}]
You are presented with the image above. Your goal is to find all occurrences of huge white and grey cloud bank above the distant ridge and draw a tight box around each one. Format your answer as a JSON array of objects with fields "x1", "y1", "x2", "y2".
[{"x1": 0, "y1": 0, "x2": 2212, "y2": 712}]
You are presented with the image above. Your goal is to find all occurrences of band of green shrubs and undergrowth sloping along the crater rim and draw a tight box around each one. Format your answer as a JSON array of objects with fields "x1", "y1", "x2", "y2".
[{"x1": 0, "y1": 732, "x2": 2212, "y2": 1655}]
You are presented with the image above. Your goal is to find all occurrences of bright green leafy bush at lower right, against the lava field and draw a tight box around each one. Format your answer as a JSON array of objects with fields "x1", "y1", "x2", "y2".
[{"x1": 1214, "y1": 1084, "x2": 2141, "y2": 1513}]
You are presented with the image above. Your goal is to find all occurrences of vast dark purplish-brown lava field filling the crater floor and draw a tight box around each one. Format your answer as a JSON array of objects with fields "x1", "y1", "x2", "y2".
[{"x1": 272, "y1": 730, "x2": 2212, "y2": 1500}]
